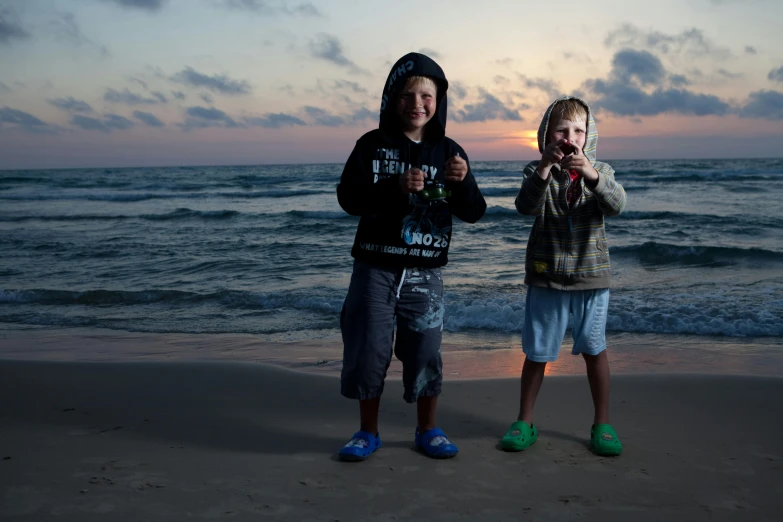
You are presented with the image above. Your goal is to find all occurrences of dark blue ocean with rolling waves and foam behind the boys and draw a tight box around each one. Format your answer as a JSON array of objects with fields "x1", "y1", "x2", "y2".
[{"x1": 0, "y1": 159, "x2": 783, "y2": 354}]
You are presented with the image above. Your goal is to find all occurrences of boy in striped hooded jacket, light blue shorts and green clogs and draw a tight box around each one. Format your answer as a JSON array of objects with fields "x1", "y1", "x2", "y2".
[{"x1": 501, "y1": 96, "x2": 626, "y2": 455}]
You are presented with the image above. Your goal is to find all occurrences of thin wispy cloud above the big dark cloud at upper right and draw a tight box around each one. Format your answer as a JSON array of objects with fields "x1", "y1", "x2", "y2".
[{"x1": 604, "y1": 24, "x2": 731, "y2": 58}]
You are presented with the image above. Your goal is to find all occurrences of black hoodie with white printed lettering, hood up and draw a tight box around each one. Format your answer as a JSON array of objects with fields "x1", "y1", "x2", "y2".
[{"x1": 337, "y1": 53, "x2": 487, "y2": 267}]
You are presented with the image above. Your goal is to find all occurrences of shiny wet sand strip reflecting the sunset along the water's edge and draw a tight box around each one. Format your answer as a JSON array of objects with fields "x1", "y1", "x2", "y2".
[{"x1": 0, "y1": 327, "x2": 783, "y2": 380}]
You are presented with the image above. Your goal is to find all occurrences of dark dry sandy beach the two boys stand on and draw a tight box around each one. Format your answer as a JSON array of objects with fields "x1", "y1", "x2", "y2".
[{"x1": 0, "y1": 360, "x2": 783, "y2": 521}]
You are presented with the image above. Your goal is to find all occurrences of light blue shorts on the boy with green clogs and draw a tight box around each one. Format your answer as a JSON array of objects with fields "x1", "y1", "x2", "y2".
[{"x1": 522, "y1": 285, "x2": 609, "y2": 362}]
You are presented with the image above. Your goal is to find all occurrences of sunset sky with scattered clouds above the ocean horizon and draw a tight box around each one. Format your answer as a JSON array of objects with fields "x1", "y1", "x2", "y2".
[{"x1": 0, "y1": 0, "x2": 783, "y2": 169}]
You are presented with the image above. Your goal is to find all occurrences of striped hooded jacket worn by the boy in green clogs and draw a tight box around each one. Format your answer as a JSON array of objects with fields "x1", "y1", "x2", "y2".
[{"x1": 514, "y1": 96, "x2": 626, "y2": 290}]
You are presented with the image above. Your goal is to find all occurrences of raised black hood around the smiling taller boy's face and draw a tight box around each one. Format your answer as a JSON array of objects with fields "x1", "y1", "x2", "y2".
[{"x1": 378, "y1": 53, "x2": 449, "y2": 143}]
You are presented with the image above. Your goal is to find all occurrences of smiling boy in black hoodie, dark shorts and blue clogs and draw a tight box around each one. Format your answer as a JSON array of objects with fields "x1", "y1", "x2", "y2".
[{"x1": 337, "y1": 53, "x2": 487, "y2": 461}]
